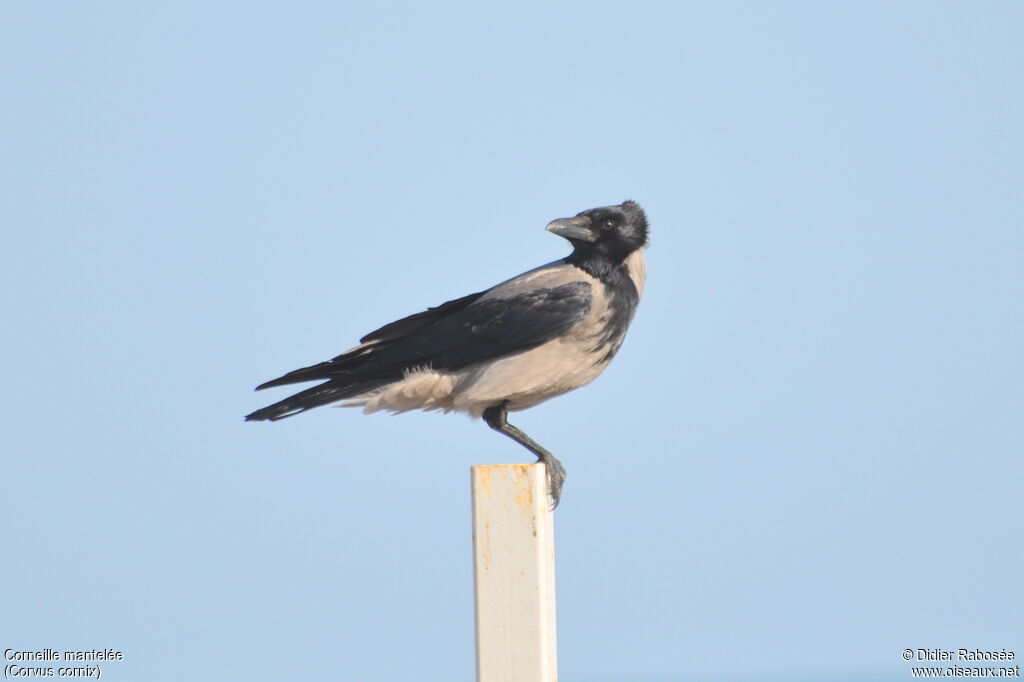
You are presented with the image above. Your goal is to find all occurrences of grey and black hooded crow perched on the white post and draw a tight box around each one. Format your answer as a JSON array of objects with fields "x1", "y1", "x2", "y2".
[{"x1": 246, "y1": 201, "x2": 648, "y2": 501}]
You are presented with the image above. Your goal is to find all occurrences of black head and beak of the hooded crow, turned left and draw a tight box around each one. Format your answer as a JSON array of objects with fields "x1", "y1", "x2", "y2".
[{"x1": 548, "y1": 201, "x2": 647, "y2": 265}]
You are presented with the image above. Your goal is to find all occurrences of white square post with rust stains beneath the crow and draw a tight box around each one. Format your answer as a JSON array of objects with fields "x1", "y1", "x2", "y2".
[{"x1": 472, "y1": 464, "x2": 558, "y2": 682}]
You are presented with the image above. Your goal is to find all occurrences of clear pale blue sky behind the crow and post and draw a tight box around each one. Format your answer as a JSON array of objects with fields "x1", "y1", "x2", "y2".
[{"x1": 0, "y1": 2, "x2": 1024, "y2": 682}]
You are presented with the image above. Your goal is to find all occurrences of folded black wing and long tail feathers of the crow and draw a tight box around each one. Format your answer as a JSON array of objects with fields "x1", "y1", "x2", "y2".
[{"x1": 246, "y1": 282, "x2": 591, "y2": 420}]
